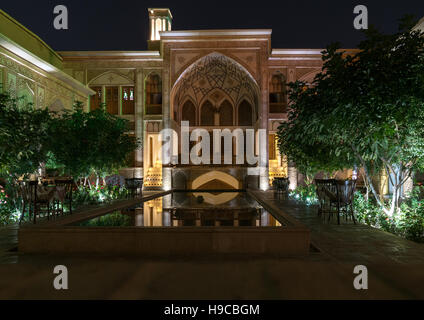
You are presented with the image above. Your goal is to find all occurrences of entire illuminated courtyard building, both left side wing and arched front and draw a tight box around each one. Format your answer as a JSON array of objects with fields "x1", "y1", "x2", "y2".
[{"x1": 0, "y1": 8, "x2": 424, "y2": 194}]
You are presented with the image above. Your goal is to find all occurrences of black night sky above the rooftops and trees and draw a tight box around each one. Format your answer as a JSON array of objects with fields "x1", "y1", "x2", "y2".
[{"x1": 0, "y1": 0, "x2": 424, "y2": 51}]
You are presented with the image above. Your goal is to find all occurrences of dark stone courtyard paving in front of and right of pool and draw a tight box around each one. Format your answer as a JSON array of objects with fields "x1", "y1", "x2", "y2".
[{"x1": 0, "y1": 191, "x2": 424, "y2": 299}]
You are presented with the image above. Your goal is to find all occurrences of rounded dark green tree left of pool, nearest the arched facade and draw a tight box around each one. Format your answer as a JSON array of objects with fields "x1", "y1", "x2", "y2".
[{"x1": 49, "y1": 102, "x2": 139, "y2": 184}]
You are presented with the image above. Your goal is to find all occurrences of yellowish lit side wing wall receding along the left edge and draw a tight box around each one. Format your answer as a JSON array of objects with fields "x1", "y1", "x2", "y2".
[{"x1": 0, "y1": 10, "x2": 94, "y2": 111}]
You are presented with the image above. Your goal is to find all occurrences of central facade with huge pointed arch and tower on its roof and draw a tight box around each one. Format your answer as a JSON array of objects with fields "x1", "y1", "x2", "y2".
[{"x1": 59, "y1": 9, "x2": 332, "y2": 189}]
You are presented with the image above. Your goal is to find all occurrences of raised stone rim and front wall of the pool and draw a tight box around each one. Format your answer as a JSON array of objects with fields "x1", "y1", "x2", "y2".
[{"x1": 18, "y1": 192, "x2": 310, "y2": 257}]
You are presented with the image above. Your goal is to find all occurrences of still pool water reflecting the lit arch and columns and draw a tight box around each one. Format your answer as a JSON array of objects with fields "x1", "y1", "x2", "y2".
[{"x1": 73, "y1": 191, "x2": 282, "y2": 227}]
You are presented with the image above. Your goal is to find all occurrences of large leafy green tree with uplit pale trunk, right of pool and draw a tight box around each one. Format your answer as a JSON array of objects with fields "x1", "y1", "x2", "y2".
[{"x1": 278, "y1": 17, "x2": 424, "y2": 216}]
